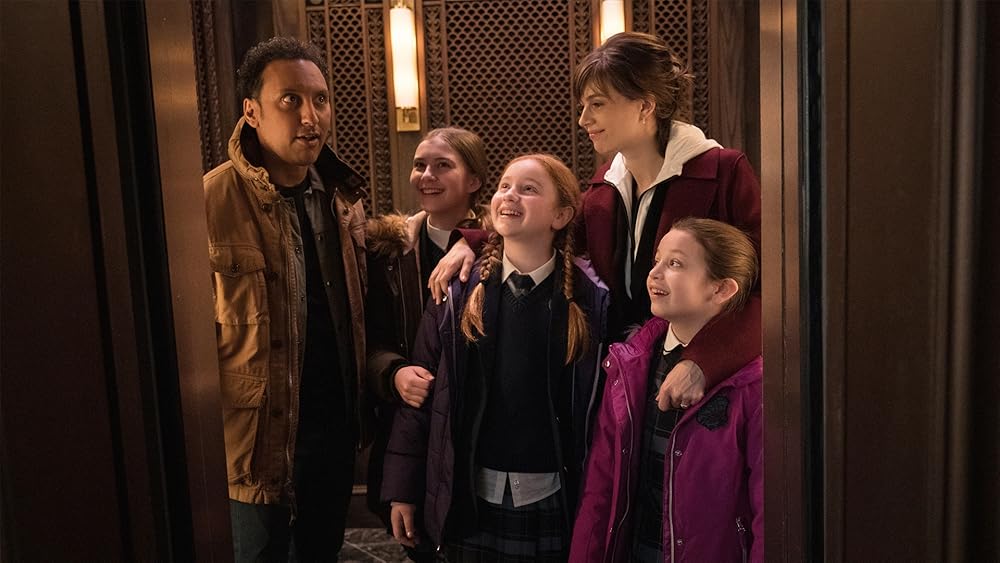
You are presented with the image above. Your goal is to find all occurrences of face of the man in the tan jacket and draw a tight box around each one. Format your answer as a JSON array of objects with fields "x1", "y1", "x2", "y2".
[{"x1": 243, "y1": 60, "x2": 331, "y2": 186}]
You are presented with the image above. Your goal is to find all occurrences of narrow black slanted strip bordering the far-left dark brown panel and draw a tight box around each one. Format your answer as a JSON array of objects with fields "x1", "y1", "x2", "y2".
[{"x1": 79, "y1": 2, "x2": 169, "y2": 559}]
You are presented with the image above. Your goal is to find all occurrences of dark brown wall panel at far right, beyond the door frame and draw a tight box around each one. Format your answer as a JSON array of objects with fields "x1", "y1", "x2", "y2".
[{"x1": 807, "y1": 1, "x2": 998, "y2": 562}]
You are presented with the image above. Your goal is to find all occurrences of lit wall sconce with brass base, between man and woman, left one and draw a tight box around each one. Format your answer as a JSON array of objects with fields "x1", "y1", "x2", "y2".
[{"x1": 389, "y1": 0, "x2": 420, "y2": 131}]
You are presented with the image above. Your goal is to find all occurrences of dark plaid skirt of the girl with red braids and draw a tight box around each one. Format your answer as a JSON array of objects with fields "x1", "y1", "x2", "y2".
[{"x1": 445, "y1": 486, "x2": 569, "y2": 563}]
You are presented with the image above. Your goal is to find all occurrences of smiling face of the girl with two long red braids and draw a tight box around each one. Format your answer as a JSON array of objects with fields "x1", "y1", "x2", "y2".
[{"x1": 490, "y1": 158, "x2": 573, "y2": 244}]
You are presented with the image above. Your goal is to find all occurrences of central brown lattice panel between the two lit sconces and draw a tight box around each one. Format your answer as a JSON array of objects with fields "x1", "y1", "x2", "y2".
[{"x1": 423, "y1": 0, "x2": 593, "y2": 209}]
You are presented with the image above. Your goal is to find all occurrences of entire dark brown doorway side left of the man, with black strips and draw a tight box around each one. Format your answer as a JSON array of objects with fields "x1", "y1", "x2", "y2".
[{"x1": 0, "y1": 0, "x2": 232, "y2": 561}]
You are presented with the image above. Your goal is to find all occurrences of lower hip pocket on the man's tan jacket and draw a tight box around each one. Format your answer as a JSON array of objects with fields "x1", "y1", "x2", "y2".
[{"x1": 220, "y1": 373, "x2": 267, "y2": 483}]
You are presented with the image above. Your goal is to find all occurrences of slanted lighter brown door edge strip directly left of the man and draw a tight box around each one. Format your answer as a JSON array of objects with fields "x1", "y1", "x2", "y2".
[{"x1": 146, "y1": 2, "x2": 233, "y2": 561}]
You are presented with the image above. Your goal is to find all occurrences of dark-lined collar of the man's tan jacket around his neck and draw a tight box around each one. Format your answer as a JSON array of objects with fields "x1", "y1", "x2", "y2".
[{"x1": 229, "y1": 117, "x2": 367, "y2": 204}]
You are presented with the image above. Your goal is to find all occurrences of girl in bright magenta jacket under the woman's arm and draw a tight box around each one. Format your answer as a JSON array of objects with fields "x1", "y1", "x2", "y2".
[{"x1": 570, "y1": 218, "x2": 764, "y2": 562}]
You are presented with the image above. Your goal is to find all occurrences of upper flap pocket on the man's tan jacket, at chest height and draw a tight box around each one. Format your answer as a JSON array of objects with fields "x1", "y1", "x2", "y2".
[{"x1": 209, "y1": 245, "x2": 268, "y2": 325}]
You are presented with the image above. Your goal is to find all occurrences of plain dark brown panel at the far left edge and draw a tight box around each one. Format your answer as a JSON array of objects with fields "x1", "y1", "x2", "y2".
[{"x1": 0, "y1": 2, "x2": 128, "y2": 561}]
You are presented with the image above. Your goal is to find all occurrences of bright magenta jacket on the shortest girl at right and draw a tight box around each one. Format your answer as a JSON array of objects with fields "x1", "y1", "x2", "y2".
[{"x1": 570, "y1": 318, "x2": 764, "y2": 563}]
